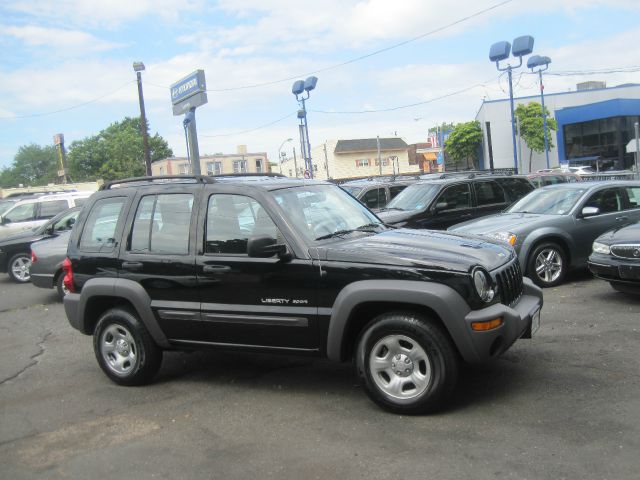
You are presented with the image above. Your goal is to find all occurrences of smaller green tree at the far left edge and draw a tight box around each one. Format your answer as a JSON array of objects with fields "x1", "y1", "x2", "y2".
[{"x1": 0, "y1": 144, "x2": 58, "y2": 187}]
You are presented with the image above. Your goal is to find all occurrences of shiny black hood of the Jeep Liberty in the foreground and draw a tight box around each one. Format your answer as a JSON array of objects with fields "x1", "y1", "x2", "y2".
[{"x1": 319, "y1": 228, "x2": 515, "y2": 272}]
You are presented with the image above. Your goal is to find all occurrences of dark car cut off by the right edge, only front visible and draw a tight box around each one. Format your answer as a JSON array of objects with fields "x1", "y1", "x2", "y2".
[{"x1": 588, "y1": 223, "x2": 640, "y2": 294}]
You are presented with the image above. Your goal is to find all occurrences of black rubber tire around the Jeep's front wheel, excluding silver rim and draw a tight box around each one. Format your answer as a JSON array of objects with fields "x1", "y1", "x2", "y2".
[{"x1": 356, "y1": 313, "x2": 458, "y2": 414}]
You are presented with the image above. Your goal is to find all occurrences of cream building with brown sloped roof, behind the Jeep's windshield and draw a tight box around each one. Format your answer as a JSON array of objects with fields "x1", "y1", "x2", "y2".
[{"x1": 276, "y1": 137, "x2": 420, "y2": 180}]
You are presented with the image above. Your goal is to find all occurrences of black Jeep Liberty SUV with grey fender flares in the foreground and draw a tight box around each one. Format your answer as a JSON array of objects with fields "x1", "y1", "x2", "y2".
[{"x1": 64, "y1": 176, "x2": 542, "y2": 413}]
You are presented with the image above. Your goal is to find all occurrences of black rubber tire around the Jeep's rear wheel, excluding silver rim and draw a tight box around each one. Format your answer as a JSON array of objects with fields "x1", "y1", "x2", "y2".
[{"x1": 93, "y1": 308, "x2": 162, "y2": 386}]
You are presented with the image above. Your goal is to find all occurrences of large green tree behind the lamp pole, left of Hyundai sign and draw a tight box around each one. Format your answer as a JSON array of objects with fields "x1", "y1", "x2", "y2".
[{"x1": 68, "y1": 117, "x2": 173, "y2": 180}]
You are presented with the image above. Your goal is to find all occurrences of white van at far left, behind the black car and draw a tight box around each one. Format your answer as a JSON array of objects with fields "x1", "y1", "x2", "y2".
[{"x1": 0, "y1": 192, "x2": 94, "y2": 239}]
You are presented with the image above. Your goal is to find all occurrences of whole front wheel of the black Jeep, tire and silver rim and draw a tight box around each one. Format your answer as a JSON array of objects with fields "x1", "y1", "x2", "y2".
[{"x1": 356, "y1": 312, "x2": 459, "y2": 414}]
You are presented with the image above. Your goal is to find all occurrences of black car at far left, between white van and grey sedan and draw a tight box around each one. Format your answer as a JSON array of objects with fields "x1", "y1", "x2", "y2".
[{"x1": 0, "y1": 207, "x2": 81, "y2": 283}]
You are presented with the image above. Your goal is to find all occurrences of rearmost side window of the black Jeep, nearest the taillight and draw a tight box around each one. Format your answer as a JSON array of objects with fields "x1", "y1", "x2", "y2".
[{"x1": 80, "y1": 197, "x2": 126, "y2": 252}]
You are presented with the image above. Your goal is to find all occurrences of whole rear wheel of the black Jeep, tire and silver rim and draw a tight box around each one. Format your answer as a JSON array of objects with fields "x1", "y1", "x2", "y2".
[{"x1": 93, "y1": 308, "x2": 162, "y2": 386}]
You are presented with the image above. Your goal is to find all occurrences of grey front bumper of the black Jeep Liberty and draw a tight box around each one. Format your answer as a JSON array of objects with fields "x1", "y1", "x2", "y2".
[{"x1": 464, "y1": 277, "x2": 543, "y2": 363}]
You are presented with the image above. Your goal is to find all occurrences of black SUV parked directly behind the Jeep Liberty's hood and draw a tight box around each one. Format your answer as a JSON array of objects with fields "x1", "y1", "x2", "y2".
[{"x1": 378, "y1": 174, "x2": 534, "y2": 229}]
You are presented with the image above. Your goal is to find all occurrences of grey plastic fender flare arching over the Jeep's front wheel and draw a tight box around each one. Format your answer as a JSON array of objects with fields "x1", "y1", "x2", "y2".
[{"x1": 327, "y1": 280, "x2": 476, "y2": 361}]
